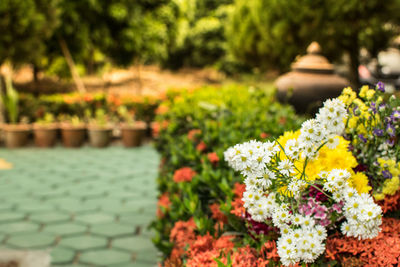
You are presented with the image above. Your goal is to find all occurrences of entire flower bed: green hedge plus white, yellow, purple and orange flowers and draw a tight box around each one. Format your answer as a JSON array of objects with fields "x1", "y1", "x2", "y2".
[{"x1": 152, "y1": 83, "x2": 400, "y2": 267}]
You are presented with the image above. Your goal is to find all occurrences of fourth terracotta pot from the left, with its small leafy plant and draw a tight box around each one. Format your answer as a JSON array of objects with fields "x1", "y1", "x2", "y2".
[{"x1": 88, "y1": 109, "x2": 112, "y2": 150}]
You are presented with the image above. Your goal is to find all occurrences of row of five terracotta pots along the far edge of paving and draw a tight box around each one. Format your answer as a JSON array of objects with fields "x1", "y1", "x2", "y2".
[{"x1": 1, "y1": 109, "x2": 147, "y2": 148}]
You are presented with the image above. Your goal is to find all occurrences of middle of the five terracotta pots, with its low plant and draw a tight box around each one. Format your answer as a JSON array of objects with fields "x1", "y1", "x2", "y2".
[{"x1": 60, "y1": 116, "x2": 86, "y2": 147}]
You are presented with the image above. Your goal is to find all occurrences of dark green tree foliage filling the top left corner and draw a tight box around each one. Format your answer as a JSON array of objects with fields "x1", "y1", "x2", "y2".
[{"x1": 0, "y1": 0, "x2": 59, "y2": 64}]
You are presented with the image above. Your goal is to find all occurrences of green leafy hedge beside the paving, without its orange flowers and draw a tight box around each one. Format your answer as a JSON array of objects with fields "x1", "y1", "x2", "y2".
[{"x1": 152, "y1": 85, "x2": 302, "y2": 257}]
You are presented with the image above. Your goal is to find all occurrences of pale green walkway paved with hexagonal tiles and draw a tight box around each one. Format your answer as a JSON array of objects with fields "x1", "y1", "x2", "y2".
[{"x1": 0, "y1": 146, "x2": 159, "y2": 267}]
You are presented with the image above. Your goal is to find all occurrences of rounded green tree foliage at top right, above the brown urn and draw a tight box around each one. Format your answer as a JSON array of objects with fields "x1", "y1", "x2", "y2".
[{"x1": 227, "y1": 0, "x2": 400, "y2": 79}]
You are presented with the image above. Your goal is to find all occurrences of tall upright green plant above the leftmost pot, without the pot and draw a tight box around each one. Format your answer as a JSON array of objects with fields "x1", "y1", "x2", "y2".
[{"x1": 0, "y1": 77, "x2": 19, "y2": 123}]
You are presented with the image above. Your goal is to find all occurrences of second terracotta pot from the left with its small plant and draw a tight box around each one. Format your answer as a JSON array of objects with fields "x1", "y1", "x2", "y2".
[{"x1": 33, "y1": 113, "x2": 58, "y2": 147}]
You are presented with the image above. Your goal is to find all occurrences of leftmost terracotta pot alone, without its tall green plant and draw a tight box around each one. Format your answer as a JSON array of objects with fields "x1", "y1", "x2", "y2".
[{"x1": 3, "y1": 124, "x2": 31, "y2": 148}]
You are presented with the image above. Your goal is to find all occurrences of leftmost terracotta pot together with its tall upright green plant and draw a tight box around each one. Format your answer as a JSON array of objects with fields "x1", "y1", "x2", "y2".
[{"x1": 1, "y1": 78, "x2": 31, "y2": 148}]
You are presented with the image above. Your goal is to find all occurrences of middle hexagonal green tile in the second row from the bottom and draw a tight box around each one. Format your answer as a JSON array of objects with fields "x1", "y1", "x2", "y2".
[{"x1": 59, "y1": 235, "x2": 107, "y2": 250}]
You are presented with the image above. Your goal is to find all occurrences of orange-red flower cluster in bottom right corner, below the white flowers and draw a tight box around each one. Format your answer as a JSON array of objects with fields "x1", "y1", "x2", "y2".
[{"x1": 325, "y1": 218, "x2": 400, "y2": 266}]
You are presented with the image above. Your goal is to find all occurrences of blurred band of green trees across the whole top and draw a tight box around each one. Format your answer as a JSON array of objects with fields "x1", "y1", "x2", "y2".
[{"x1": 0, "y1": 0, "x2": 400, "y2": 83}]
